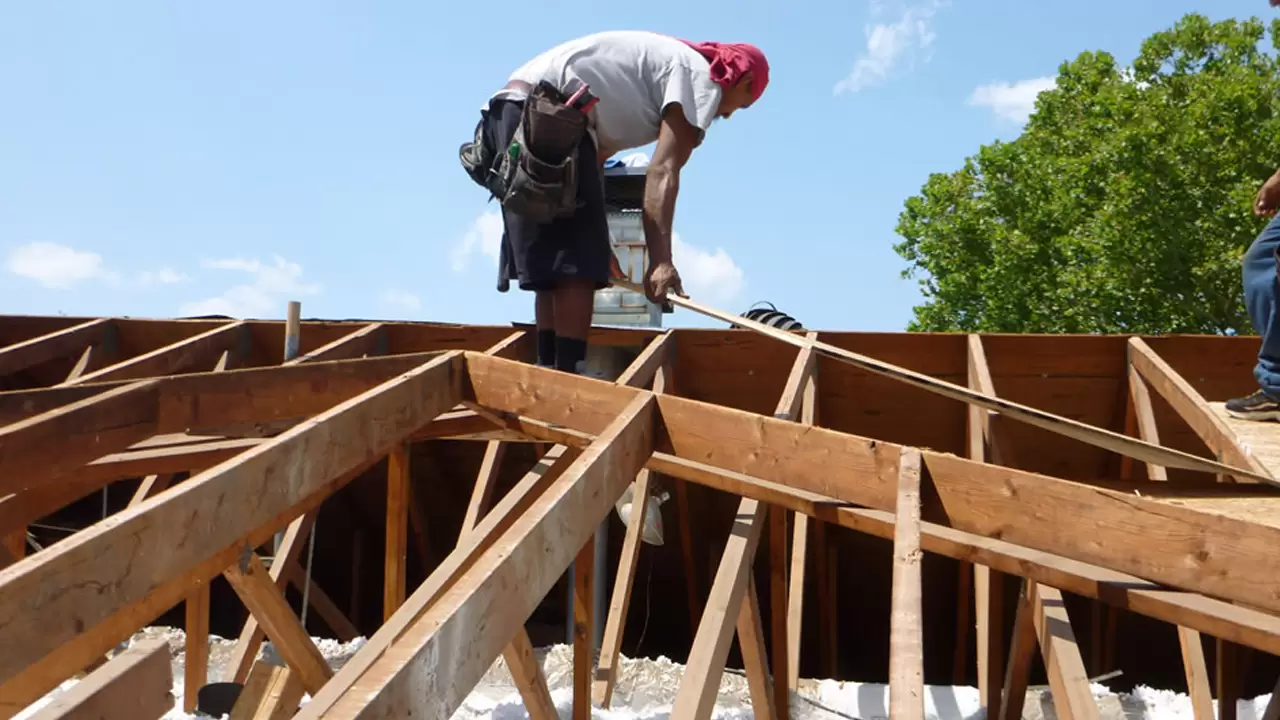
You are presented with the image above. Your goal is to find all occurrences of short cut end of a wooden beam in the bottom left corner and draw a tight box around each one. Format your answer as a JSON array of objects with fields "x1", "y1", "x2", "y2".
[{"x1": 31, "y1": 639, "x2": 173, "y2": 720}]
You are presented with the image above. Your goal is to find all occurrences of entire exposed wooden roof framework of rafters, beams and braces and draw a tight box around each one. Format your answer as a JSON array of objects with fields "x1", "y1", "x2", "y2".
[{"x1": 0, "y1": 318, "x2": 1280, "y2": 720}]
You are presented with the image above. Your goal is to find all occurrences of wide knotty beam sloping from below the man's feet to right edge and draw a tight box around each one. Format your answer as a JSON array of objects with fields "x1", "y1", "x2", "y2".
[{"x1": 467, "y1": 354, "x2": 1280, "y2": 612}]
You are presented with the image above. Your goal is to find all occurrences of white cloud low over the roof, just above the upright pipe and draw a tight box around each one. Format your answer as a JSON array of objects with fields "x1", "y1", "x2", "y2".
[{"x1": 182, "y1": 255, "x2": 320, "y2": 318}]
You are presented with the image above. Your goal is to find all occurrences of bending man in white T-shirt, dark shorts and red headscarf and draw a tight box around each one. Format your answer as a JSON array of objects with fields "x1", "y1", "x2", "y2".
[{"x1": 461, "y1": 31, "x2": 769, "y2": 373}]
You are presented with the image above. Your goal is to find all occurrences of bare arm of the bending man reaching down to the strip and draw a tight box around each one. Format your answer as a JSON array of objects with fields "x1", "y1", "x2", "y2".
[{"x1": 641, "y1": 104, "x2": 703, "y2": 301}]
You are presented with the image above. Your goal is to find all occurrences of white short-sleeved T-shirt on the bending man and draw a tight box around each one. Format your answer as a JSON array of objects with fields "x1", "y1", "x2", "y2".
[{"x1": 499, "y1": 31, "x2": 721, "y2": 156}]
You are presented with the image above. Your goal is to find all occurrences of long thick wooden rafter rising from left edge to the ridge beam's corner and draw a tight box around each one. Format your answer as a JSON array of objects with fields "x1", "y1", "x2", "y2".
[{"x1": 0, "y1": 354, "x2": 463, "y2": 683}]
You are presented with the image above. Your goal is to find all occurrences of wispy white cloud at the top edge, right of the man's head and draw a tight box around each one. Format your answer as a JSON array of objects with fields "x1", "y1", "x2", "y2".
[{"x1": 832, "y1": 0, "x2": 945, "y2": 95}]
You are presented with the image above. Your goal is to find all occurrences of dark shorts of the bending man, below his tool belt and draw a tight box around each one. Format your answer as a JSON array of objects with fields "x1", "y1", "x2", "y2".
[{"x1": 484, "y1": 99, "x2": 613, "y2": 292}]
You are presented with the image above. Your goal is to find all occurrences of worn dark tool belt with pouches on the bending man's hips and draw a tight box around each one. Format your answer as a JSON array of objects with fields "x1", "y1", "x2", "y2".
[{"x1": 458, "y1": 81, "x2": 594, "y2": 223}]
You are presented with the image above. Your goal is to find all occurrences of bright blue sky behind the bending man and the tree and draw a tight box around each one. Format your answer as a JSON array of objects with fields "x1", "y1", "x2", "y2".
[{"x1": 0, "y1": 0, "x2": 1280, "y2": 331}]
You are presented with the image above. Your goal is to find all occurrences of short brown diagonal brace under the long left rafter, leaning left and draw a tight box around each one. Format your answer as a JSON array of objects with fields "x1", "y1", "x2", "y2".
[{"x1": 223, "y1": 550, "x2": 333, "y2": 693}]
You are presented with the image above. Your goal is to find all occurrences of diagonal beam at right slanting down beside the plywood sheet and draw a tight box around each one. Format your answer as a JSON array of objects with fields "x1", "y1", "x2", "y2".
[{"x1": 1128, "y1": 337, "x2": 1275, "y2": 482}]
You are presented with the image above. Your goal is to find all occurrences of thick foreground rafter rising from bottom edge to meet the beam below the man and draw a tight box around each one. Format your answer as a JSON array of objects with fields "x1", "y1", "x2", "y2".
[{"x1": 297, "y1": 392, "x2": 654, "y2": 720}]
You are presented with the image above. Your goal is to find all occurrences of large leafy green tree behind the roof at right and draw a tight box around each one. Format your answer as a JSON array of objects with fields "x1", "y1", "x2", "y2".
[{"x1": 895, "y1": 14, "x2": 1280, "y2": 333}]
